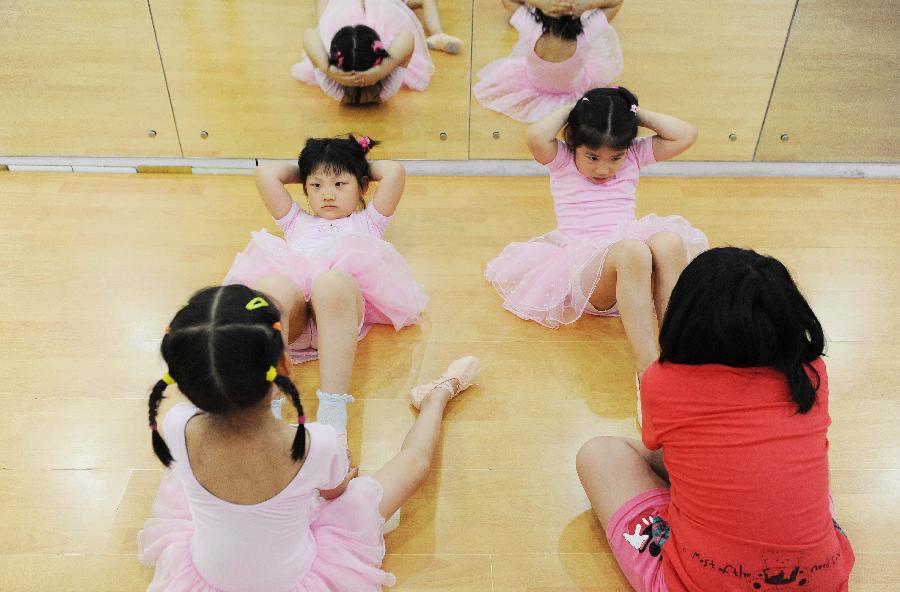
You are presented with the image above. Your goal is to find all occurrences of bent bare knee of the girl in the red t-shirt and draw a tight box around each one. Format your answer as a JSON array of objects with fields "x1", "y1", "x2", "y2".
[{"x1": 575, "y1": 436, "x2": 669, "y2": 527}]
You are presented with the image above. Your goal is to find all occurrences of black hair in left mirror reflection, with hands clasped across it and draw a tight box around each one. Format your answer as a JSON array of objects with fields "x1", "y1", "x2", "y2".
[{"x1": 328, "y1": 25, "x2": 391, "y2": 105}]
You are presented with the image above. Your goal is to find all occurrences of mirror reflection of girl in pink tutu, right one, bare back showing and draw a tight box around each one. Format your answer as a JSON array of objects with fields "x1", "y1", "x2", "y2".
[{"x1": 472, "y1": 0, "x2": 622, "y2": 122}]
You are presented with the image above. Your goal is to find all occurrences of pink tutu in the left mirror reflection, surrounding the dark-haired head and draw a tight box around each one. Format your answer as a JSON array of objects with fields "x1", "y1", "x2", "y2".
[{"x1": 292, "y1": 0, "x2": 434, "y2": 101}]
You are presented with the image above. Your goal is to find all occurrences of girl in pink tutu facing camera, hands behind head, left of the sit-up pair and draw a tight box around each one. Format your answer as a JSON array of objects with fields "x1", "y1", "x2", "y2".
[{"x1": 224, "y1": 135, "x2": 428, "y2": 418}]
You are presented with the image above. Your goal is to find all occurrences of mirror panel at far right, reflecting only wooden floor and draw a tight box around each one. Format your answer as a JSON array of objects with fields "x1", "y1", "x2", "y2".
[{"x1": 757, "y1": 0, "x2": 900, "y2": 162}]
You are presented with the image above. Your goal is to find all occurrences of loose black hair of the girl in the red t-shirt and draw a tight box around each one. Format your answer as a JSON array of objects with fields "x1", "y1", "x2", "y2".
[{"x1": 659, "y1": 247, "x2": 825, "y2": 413}]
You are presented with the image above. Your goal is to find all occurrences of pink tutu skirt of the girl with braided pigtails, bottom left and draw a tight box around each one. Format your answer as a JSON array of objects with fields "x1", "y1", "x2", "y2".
[{"x1": 138, "y1": 470, "x2": 396, "y2": 592}]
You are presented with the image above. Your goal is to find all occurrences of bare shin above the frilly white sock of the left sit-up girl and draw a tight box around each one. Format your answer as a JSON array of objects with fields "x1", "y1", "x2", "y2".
[{"x1": 311, "y1": 270, "x2": 365, "y2": 393}]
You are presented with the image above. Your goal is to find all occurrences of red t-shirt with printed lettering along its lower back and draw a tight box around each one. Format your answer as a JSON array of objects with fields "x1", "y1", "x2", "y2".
[{"x1": 641, "y1": 359, "x2": 854, "y2": 592}]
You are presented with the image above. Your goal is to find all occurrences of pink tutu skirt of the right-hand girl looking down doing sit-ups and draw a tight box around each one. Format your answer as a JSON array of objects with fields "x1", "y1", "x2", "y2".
[{"x1": 485, "y1": 214, "x2": 709, "y2": 329}]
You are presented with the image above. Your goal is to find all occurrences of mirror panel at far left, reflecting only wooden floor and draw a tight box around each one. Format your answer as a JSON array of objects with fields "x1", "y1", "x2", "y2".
[{"x1": 0, "y1": 0, "x2": 181, "y2": 156}]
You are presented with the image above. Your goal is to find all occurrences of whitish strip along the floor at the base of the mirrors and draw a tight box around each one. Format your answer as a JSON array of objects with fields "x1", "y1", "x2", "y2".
[{"x1": 0, "y1": 156, "x2": 900, "y2": 179}]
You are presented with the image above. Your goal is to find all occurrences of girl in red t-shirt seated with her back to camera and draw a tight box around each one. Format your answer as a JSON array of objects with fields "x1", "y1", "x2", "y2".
[{"x1": 576, "y1": 247, "x2": 854, "y2": 592}]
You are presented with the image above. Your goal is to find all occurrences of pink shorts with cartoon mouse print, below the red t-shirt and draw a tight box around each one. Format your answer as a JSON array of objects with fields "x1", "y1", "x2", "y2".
[{"x1": 606, "y1": 487, "x2": 672, "y2": 592}]
